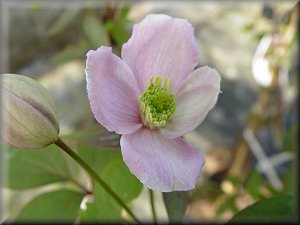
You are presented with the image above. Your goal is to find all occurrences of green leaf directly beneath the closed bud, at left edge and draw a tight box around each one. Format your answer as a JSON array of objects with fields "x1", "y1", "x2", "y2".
[{"x1": 4, "y1": 145, "x2": 78, "y2": 189}]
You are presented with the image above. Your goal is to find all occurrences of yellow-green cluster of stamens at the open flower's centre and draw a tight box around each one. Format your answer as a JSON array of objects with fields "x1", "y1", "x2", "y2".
[{"x1": 140, "y1": 76, "x2": 176, "y2": 129}]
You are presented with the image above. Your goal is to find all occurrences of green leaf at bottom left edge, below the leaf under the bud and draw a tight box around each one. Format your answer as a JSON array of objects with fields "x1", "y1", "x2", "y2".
[{"x1": 16, "y1": 190, "x2": 83, "y2": 223}]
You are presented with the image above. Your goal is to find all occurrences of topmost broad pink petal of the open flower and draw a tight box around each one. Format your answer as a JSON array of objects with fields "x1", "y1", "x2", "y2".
[{"x1": 122, "y1": 14, "x2": 199, "y2": 92}]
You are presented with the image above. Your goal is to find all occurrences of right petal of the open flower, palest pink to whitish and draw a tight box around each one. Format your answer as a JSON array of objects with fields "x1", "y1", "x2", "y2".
[{"x1": 161, "y1": 66, "x2": 221, "y2": 138}]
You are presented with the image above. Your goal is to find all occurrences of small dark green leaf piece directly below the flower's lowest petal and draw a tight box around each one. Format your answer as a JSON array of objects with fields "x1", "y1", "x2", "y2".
[{"x1": 163, "y1": 191, "x2": 189, "y2": 222}]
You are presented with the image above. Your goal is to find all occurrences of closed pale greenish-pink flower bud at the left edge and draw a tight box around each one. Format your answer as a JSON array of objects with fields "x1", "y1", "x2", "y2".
[{"x1": 1, "y1": 74, "x2": 59, "y2": 149}]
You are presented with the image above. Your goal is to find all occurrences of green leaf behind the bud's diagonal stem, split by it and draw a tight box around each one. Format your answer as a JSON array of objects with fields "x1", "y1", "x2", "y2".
[{"x1": 80, "y1": 152, "x2": 142, "y2": 222}]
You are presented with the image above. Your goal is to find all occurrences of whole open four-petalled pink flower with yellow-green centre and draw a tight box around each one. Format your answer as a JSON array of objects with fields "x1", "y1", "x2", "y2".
[{"x1": 86, "y1": 14, "x2": 220, "y2": 192}]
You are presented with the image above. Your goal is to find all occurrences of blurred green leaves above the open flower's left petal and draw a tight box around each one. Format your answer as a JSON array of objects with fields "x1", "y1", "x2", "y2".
[{"x1": 47, "y1": 5, "x2": 130, "y2": 64}]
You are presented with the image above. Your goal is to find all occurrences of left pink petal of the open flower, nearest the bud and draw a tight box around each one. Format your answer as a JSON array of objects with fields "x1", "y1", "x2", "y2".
[{"x1": 85, "y1": 47, "x2": 142, "y2": 134}]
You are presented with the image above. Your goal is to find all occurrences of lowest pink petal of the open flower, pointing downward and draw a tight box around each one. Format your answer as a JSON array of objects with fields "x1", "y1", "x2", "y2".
[{"x1": 121, "y1": 128, "x2": 205, "y2": 192}]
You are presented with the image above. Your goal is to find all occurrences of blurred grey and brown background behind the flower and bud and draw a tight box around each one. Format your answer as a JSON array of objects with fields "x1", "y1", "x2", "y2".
[{"x1": 1, "y1": 1, "x2": 299, "y2": 222}]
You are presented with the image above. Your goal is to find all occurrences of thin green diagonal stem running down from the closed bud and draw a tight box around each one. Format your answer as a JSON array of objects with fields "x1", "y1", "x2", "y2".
[{"x1": 55, "y1": 138, "x2": 141, "y2": 224}]
